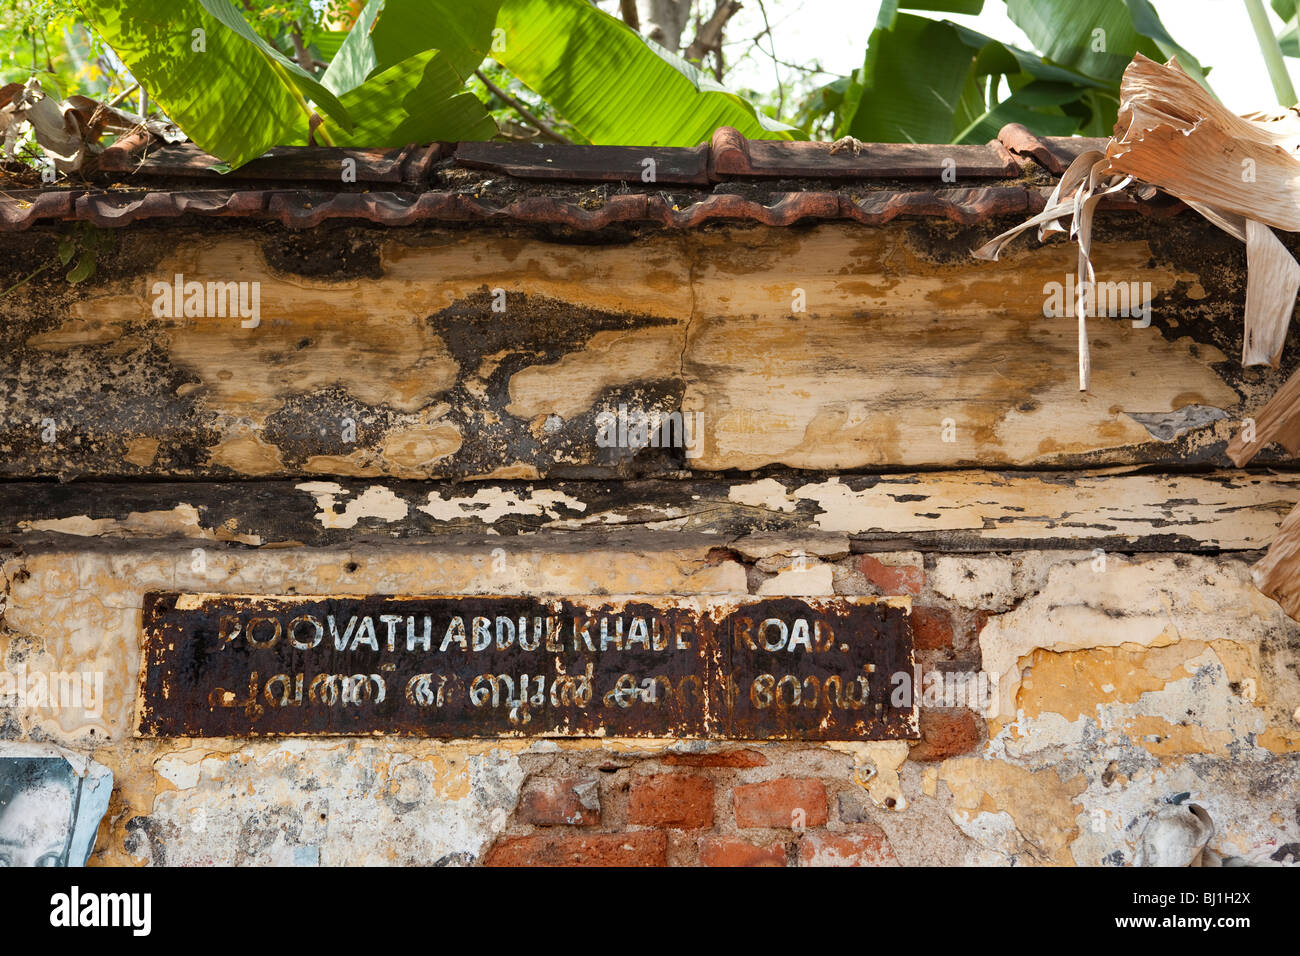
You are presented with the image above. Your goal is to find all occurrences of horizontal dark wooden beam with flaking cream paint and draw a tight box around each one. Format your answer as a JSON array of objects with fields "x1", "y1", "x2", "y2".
[{"x1": 0, "y1": 471, "x2": 1300, "y2": 551}]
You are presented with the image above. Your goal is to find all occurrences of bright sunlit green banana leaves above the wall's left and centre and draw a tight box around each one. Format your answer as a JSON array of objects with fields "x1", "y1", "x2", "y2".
[{"x1": 65, "y1": 0, "x2": 805, "y2": 168}]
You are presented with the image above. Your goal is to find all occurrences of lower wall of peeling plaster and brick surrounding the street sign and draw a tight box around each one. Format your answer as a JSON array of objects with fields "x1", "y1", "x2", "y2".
[{"x1": 0, "y1": 538, "x2": 1300, "y2": 865}]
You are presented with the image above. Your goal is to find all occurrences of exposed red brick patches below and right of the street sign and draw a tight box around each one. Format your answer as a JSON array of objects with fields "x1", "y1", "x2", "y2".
[{"x1": 470, "y1": 554, "x2": 1024, "y2": 868}]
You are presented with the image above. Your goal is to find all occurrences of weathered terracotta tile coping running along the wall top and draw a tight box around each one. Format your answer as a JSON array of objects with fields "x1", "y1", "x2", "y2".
[{"x1": 0, "y1": 125, "x2": 1177, "y2": 232}]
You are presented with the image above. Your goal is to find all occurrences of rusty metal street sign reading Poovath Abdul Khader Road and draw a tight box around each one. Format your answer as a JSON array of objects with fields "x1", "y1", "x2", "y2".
[{"x1": 138, "y1": 592, "x2": 917, "y2": 740}]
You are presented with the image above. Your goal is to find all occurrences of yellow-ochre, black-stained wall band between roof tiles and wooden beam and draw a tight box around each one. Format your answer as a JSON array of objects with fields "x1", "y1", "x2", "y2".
[{"x1": 0, "y1": 215, "x2": 1283, "y2": 479}]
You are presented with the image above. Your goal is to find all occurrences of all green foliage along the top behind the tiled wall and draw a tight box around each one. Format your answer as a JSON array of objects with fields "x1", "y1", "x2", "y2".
[{"x1": 0, "y1": 0, "x2": 1227, "y2": 160}]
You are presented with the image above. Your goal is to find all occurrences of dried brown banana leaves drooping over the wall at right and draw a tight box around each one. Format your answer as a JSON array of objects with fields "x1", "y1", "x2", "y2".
[{"x1": 974, "y1": 55, "x2": 1300, "y2": 620}]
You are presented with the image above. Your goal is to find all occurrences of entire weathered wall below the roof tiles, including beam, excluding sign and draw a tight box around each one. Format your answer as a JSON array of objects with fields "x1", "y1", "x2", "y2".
[{"x1": 0, "y1": 216, "x2": 1300, "y2": 865}]
